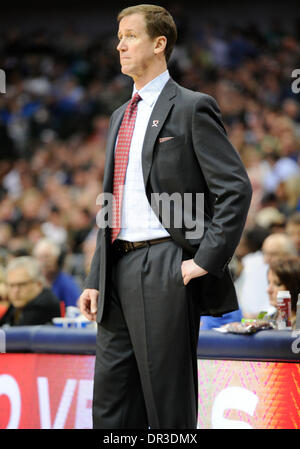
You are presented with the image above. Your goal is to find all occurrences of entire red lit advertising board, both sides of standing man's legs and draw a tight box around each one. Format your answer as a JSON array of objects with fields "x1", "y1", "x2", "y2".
[{"x1": 0, "y1": 354, "x2": 300, "y2": 429}]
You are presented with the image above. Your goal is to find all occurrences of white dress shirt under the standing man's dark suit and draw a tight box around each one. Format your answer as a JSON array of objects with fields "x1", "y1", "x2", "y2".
[{"x1": 118, "y1": 70, "x2": 170, "y2": 242}]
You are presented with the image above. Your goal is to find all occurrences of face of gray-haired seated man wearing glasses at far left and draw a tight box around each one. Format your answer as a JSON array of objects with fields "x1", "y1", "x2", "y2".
[{"x1": 6, "y1": 267, "x2": 42, "y2": 308}]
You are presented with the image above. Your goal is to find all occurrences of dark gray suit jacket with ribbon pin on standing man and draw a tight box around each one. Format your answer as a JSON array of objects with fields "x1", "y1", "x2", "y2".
[{"x1": 85, "y1": 79, "x2": 252, "y2": 322}]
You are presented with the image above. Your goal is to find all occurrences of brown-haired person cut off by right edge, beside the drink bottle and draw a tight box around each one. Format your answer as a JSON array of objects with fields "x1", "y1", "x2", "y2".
[{"x1": 268, "y1": 256, "x2": 300, "y2": 328}]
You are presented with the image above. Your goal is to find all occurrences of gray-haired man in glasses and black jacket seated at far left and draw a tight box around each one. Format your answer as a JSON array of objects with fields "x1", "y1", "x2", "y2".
[{"x1": 0, "y1": 256, "x2": 60, "y2": 326}]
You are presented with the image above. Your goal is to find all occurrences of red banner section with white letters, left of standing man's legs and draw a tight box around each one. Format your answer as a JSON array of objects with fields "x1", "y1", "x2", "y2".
[{"x1": 0, "y1": 354, "x2": 95, "y2": 429}]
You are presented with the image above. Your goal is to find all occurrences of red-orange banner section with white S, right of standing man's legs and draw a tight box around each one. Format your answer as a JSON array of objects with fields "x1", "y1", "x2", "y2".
[{"x1": 198, "y1": 360, "x2": 300, "y2": 429}]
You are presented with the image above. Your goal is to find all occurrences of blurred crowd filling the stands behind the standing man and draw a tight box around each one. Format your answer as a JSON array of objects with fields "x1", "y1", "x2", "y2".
[{"x1": 0, "y1": 11, "x2": 300, "y2": 326}]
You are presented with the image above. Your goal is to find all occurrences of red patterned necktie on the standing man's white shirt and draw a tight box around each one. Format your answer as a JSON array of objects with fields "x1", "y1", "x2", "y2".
[{"x1": 111, "y1": 93, "x2": 141, "y2": 242}]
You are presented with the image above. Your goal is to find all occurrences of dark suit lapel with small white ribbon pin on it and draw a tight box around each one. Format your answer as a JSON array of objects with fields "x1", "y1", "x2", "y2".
[{"x1": 142, "y1": 79, "x2": 176, "y2": 188}]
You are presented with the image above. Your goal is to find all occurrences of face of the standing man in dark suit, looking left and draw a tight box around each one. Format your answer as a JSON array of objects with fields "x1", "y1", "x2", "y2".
[{"x1": 117, "y1": 14, "x2": 156, "y2": 80}]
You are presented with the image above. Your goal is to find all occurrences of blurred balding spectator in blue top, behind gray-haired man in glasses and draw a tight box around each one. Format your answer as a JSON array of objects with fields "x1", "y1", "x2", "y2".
[{"x1": 33, "y1": 239, "x2": 81, "y2": 315}]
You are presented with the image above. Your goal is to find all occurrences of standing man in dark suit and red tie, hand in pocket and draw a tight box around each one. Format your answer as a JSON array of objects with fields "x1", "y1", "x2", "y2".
[{"x1": 80, "y1": 5, "x2": 251, "y2": 429}]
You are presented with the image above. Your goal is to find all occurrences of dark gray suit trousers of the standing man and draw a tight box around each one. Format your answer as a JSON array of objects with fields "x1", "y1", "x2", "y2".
[{"x1": 93, "y1": 240, "x2": 200, "y2": 429}]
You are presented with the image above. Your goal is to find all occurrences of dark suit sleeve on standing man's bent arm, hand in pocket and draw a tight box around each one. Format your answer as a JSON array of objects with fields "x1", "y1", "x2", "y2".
[{"x1": 192, "y1": 95, "x2": 252, "y2": 277}]
